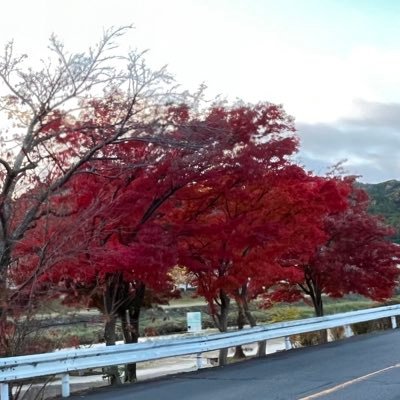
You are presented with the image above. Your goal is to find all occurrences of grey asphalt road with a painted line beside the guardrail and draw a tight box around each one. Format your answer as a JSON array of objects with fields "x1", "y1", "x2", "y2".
[{"x1": 73, "y1": 329, "x2": 400, "y2": 400}]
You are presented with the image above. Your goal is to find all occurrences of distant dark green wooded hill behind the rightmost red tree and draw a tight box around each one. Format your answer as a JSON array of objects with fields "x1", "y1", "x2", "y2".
[{"x1": 360, "y1": 180, "x2": 400, "y2": 243}]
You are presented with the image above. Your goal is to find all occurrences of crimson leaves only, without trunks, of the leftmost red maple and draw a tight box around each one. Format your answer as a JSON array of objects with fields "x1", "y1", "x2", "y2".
[{"x1": 13, "y1": 98, "x2": 297, "y2": 312}]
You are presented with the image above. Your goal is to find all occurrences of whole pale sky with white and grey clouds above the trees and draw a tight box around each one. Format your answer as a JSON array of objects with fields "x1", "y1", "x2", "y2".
[{"x1": 0, "y1": 0, "x2": 400, "y2": 183}]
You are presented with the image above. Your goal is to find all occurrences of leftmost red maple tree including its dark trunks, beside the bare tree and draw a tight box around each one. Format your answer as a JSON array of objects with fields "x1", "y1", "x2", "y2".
[{"x1": 13, "y1": 103, "x2": 295, "y2": 379}]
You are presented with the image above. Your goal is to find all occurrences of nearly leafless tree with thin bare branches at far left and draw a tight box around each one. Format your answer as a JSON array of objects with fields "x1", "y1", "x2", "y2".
[{"x1": 0, "y1": 26, "x2": 182, "y2": 330}]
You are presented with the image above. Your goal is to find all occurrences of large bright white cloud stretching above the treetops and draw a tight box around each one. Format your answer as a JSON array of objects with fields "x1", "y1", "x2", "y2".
[{"x1": 0, "y1": 0, "x2": 400, "y2": 122}]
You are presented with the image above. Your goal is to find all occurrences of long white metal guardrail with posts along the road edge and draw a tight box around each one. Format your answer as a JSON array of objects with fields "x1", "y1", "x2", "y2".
[{"x1": 0, "y1": 305, "x2": 400, "y2": 400}]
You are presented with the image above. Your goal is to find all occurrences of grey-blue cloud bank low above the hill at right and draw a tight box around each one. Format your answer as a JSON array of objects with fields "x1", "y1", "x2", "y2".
[{"x1": 298, "y1": 101, "x2": 400, "y2": 183}]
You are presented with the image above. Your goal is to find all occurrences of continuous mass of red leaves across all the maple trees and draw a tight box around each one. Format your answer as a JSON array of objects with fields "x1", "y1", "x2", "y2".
[{"x1": 11, "y1": 97, "x2": 398, "y2": 334}]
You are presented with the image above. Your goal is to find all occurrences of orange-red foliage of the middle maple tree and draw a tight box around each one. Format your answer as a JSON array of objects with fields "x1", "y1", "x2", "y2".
[{"x1": 159, "y1": 105, "x2": 308, "y2": 329}]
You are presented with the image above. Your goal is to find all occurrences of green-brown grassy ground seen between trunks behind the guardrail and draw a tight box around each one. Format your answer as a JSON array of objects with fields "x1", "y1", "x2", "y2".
[{"x1": 25, "y1": 291, "x2": 400, "y2": 347}]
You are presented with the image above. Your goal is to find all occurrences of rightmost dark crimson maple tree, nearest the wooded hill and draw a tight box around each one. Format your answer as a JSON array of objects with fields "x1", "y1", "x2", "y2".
[{"x1": 268, "y1": 179, "x2": 400, "y2": 315}]
